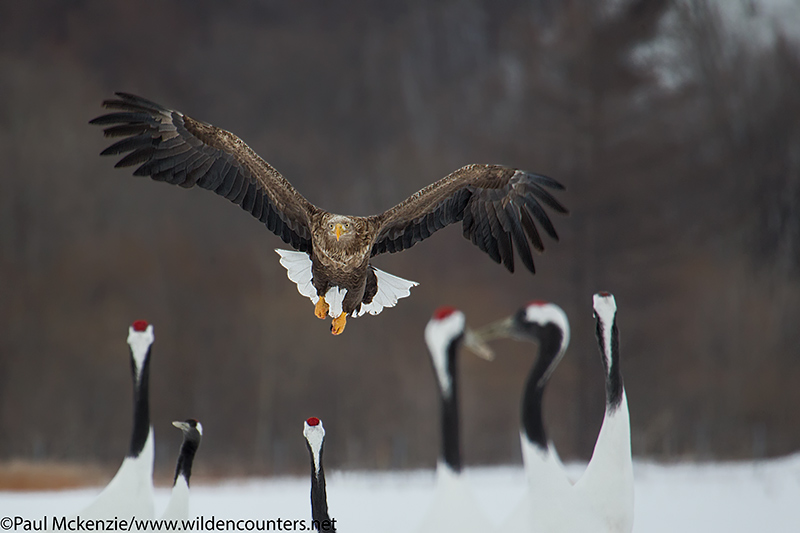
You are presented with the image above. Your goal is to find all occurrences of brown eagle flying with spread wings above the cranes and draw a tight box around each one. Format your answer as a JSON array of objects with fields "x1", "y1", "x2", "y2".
[{"x1": 90, "y1": 93, "x2": 567, "y2": 335}]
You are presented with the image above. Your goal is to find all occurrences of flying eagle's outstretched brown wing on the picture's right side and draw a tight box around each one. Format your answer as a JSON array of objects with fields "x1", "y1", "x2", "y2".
[{"x1": 370, "y1": 165, "x2": 568, "y2": 272}]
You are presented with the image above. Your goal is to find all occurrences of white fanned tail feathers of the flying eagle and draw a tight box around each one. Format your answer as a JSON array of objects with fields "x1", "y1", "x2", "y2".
[{"x1": 275, "y1": 249, "x2": 419, "y2": 318}]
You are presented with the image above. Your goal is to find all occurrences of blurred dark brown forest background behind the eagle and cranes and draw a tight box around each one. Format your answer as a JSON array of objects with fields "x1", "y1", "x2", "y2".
[{"x1": 0, "y1": 0, "x2": 800, "y2": 480}]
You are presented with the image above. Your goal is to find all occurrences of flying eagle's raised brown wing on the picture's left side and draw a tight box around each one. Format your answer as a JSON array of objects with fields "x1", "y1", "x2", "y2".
[{"x1": 89, "y1": 93, "x2": 317, "y2": 252}]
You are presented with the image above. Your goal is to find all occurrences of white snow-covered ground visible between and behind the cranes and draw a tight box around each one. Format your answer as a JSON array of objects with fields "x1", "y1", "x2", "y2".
[{"x1": 0, "y1": 454, "x2": 800, "y2": 533}]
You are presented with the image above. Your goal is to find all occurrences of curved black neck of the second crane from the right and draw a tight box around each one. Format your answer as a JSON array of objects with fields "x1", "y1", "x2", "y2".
[{"x1": 522, "y1": 323, "x2": 564, "y2": 450}]
